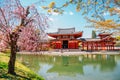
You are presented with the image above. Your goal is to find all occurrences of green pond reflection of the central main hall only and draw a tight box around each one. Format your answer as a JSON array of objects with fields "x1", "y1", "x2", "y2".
[{"x1": 48, "y1": 56, "x2": 84, "y2": 75}]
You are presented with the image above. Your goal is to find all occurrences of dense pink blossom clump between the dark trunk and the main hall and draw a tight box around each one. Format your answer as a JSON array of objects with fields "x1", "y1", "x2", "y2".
[{"x1": 17, "y1": 27, "x2": 41, "y2": 51}]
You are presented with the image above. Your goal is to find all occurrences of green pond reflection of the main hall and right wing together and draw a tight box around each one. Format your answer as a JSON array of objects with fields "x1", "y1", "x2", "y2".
[{"x1": 48, "y1": 54, "x2": 116, "y2": 75}]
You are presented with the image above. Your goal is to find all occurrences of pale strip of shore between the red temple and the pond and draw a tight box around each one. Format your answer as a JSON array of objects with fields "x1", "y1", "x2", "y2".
[{"x1": 18, "y1": 51, "x2": 120, "y2": 56}]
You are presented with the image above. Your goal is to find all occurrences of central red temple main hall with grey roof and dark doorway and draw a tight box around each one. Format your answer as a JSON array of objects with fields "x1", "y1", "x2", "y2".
[{"x1": 48, "y1": 28, "x2": 82, "y2": 49}]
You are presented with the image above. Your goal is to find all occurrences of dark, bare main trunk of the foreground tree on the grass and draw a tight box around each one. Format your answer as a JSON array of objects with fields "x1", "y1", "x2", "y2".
[{"x1": 8, "y1": 33, "x2": 18, "y2": 75}]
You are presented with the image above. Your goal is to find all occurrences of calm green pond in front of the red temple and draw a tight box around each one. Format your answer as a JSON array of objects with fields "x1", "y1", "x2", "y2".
[{"x1": 17, "y1": 54, "x2": 120, "y2": 80}]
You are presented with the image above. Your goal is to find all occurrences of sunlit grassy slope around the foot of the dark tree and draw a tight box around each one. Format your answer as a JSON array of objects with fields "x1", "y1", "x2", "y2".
[{"x1": 0, "y1": 53, "x2": 44, "y2": 80}]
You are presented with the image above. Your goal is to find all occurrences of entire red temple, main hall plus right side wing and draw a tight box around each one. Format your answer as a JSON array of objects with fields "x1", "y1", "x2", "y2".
[{"x1": 48, "y1": 28, "x2": 115, "y2": 51}]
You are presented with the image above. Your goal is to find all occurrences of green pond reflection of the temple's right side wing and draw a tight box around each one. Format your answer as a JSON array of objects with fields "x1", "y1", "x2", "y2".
[{"x1": 83, "y1": 54, "x2": 116, "y2": 71}]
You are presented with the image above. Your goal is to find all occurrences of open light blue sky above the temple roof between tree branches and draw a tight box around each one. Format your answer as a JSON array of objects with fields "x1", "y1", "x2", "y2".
[{"x1": 20, "y1": 0, "x2": 99, "y2": 38}]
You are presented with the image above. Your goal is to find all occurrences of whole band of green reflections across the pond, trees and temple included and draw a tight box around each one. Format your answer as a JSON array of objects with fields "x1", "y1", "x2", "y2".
[{"x1": 19, "y1": 54, "x2": 116, "y2": 75}]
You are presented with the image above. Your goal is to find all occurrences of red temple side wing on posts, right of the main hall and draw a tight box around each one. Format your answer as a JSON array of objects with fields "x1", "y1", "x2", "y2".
[{"x1": 82, "y1": 33, "x2": 115, "y2": 51}]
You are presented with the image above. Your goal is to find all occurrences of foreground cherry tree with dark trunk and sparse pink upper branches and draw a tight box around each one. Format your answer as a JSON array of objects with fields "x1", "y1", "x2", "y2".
[{"x1": 0, "y1": 0, "x2": 48, "y2": 75}]
